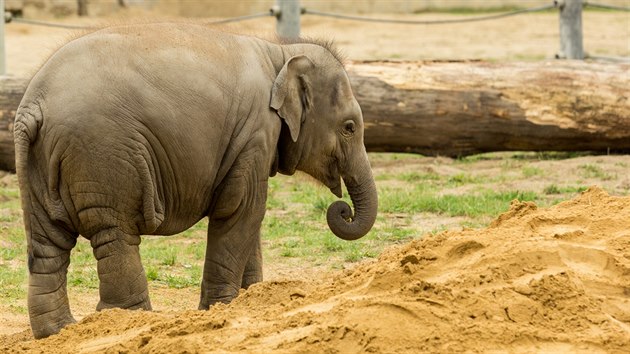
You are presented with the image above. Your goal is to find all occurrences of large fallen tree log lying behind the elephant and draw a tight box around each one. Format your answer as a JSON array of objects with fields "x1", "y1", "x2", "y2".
[{"x1": 0, "y1": 61, "x2": 630, "y2": 170}]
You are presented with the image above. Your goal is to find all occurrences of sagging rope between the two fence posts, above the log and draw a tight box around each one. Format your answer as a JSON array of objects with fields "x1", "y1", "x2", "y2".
[{"x1": 304, "y1": 5, "x2": 556, "y2": 25}]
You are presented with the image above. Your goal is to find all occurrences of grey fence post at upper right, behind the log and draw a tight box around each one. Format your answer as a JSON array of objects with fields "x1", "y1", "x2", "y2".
[{"x1": 559, "y1": 0, "x2": 584, "y2": 60}]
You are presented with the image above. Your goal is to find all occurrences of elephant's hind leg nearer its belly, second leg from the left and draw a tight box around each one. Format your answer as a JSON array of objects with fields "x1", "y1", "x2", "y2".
[{"x1": 90, "y1": 227, "x2": 151, "y2": 310}]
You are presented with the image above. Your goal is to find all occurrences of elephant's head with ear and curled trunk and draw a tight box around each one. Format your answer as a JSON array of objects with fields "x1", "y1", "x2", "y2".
[{"x1": 271, "y1": 45, "x2": 378, "y2": 240}]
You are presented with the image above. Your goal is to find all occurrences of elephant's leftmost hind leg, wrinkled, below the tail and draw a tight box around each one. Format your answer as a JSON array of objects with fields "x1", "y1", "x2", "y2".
[{"x1": 25, "y1": 203, "x2": 77, "y2": 339}]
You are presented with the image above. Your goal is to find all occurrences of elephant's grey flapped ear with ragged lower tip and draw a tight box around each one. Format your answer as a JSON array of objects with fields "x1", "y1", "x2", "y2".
[{"x1": 270, "y1": 55, "x2": 314, "y2": 142}]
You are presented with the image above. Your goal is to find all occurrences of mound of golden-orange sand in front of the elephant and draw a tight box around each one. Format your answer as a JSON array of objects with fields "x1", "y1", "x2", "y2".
[{"x1": 0, "y1": 188, "x2": 630, "y2": 353}]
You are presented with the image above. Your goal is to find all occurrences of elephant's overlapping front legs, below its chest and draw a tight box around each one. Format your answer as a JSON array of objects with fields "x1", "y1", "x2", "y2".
[{"x1": 199, "y1": 174, "x2": 267, "y2": 310}]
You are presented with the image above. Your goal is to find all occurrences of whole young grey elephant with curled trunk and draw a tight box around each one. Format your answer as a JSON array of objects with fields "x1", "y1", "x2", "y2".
[{"x1": 14, "y1": 24, "x2": 377, "y2": 338}]
